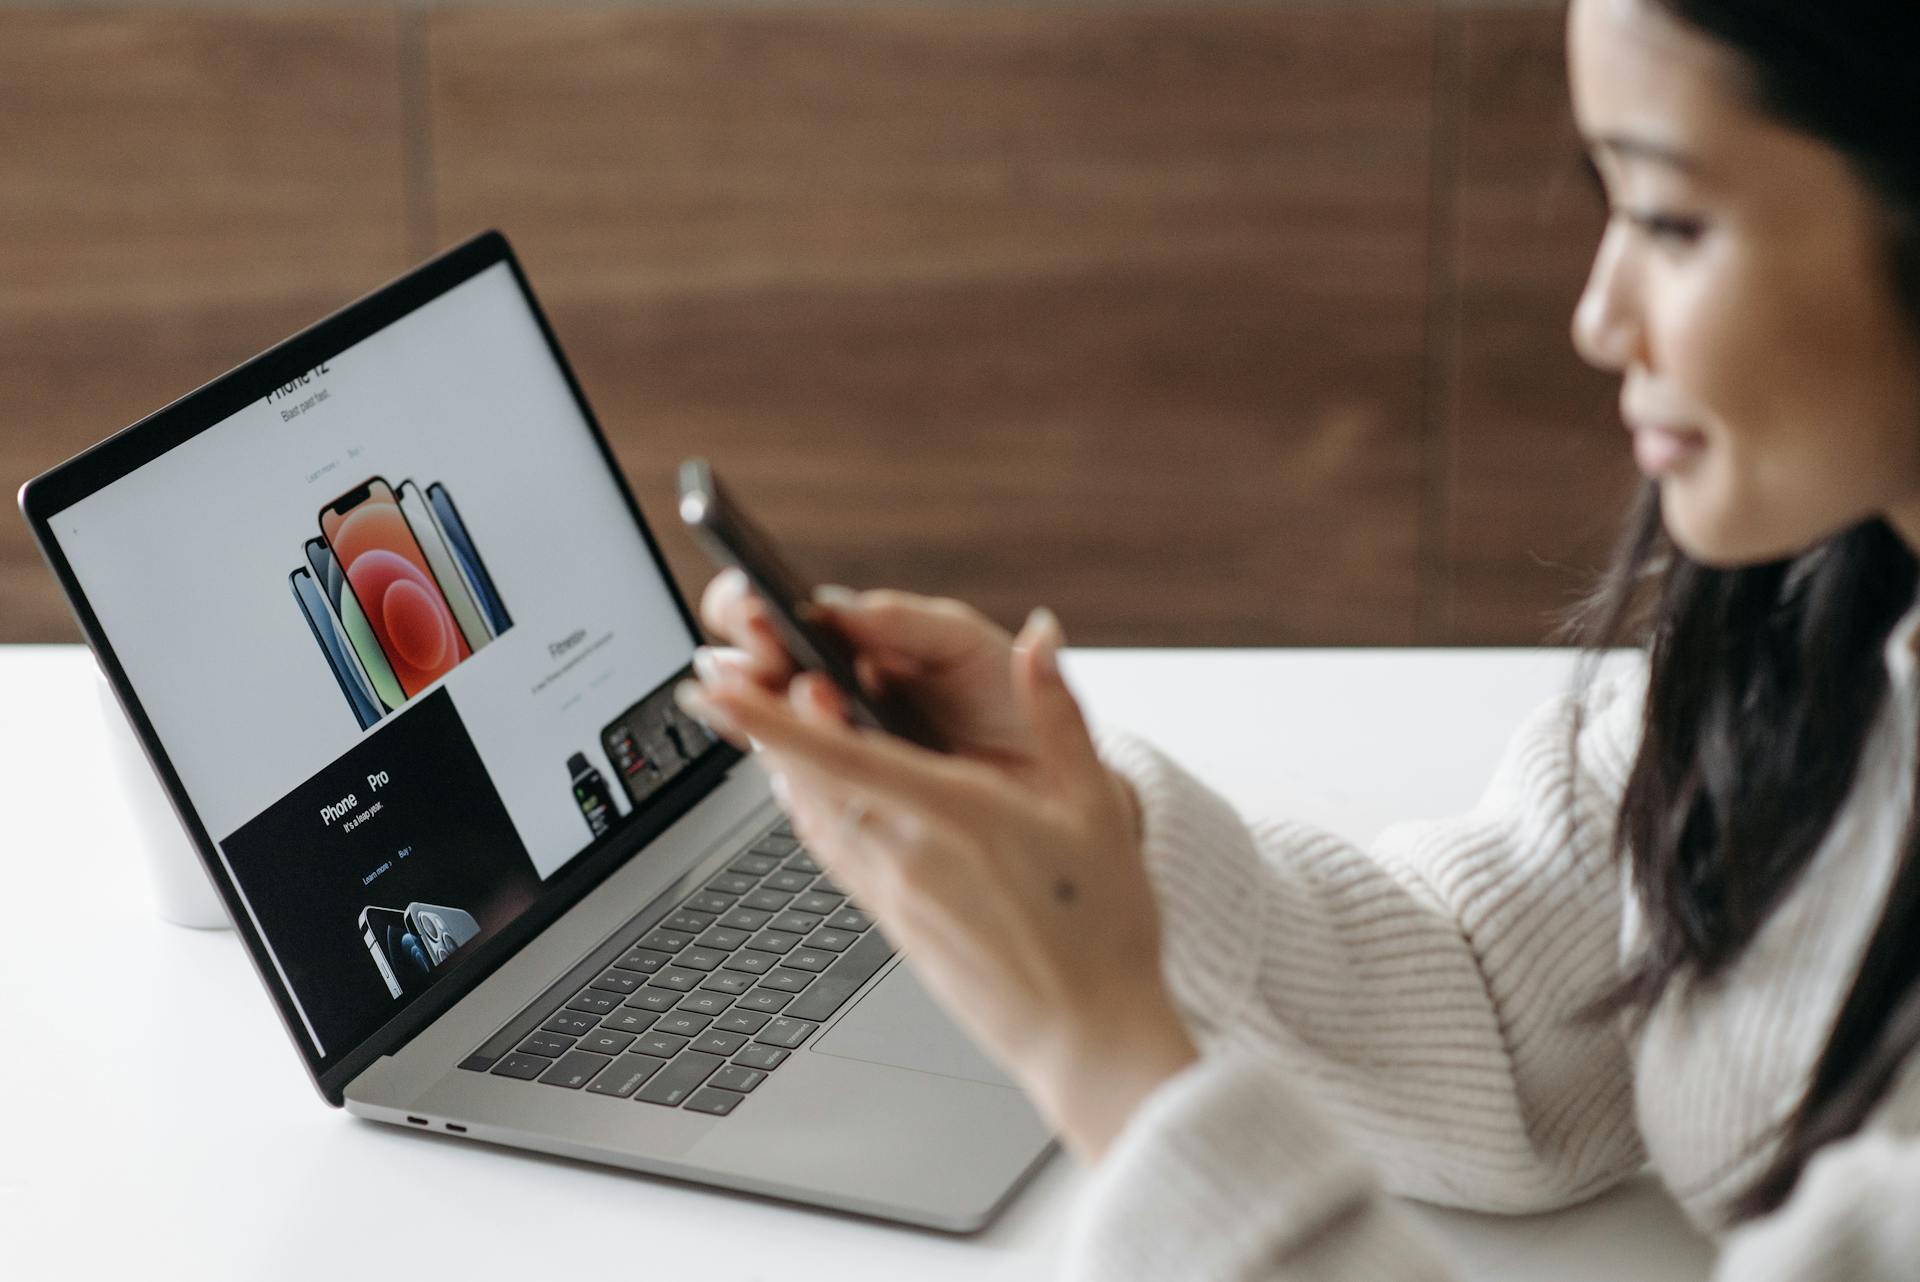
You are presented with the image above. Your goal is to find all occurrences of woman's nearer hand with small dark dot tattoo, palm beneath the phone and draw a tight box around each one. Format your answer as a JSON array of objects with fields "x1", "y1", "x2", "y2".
[{"x1": 680, "y1": 610, "x2": 1196, "y2": 1159}]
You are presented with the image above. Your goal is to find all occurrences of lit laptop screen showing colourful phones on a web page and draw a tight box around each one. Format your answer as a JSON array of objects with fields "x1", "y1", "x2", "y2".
[{"x1": 48, "y1": 249, "x2": 712, "y2": 1067}]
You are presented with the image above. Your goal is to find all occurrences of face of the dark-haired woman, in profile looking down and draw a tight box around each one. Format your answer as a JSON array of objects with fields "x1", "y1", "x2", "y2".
[{"x1": 1567, "y1": 0, "x2": 1920, "y2": 566}]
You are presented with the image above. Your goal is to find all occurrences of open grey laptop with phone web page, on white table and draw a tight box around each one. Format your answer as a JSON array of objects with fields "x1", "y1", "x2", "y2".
[{"x1": 21, "y1": 232, "x2": 1052, "y2": 1232}]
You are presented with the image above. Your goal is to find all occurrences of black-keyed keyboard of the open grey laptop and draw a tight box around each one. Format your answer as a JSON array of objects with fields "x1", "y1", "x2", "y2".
[{"x1": 461, "y1": 819, "x2": 893, "y2": 1117}]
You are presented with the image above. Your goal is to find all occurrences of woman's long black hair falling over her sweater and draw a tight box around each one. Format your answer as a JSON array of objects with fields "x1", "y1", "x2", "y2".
[{"x1": 1576, "y1": 0, "x2": 1920, "y2": 1219}]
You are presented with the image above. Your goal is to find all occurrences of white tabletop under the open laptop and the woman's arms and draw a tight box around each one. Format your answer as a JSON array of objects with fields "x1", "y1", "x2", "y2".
[{"x1": 0, "y1": 647, "x2": 1711, "y2": 1282}]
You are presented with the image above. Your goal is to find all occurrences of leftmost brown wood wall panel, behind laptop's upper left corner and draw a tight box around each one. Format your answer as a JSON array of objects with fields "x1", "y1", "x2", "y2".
[{"x1": 0, "y1": 8, "x2": 409, "y2": 641}]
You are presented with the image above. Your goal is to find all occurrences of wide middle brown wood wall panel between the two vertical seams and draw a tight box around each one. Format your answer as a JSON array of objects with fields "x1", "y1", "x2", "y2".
[{"x1": 428, "y1": 6, "x2": 1432, "y2": 645}]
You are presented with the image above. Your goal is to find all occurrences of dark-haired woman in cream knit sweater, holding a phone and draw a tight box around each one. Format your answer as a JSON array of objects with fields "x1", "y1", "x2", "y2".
[{"x1": 682, "y1": 0, "x2": 1920, "y2": 1280}]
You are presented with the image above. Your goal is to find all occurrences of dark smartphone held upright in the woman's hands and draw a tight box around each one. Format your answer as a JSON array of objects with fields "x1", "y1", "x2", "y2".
[{"x1": 680, "y1": 459, "x2": 941, "y2": 748}]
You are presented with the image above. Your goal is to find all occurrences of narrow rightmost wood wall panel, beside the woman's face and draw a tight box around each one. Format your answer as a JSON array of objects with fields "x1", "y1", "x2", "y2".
[{"x1": 1436, "y1": 10, "x2": 1634, "y2": 645}]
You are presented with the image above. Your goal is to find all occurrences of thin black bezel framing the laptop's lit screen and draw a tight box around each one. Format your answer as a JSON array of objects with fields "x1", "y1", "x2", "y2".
[{"x1": 19, "y1": 230, "x2": 741, "y2": 1107}]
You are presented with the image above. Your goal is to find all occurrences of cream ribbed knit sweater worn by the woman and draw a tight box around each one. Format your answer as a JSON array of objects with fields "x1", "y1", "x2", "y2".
[{"x1": 1068, "y1": 610, "x2": 1920, "y2": 1282}]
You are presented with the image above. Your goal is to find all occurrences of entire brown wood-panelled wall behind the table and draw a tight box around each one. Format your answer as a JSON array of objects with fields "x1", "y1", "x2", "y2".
[{"x1": 0, "y1": 0, "x2": 1630, "y2": 645}]
